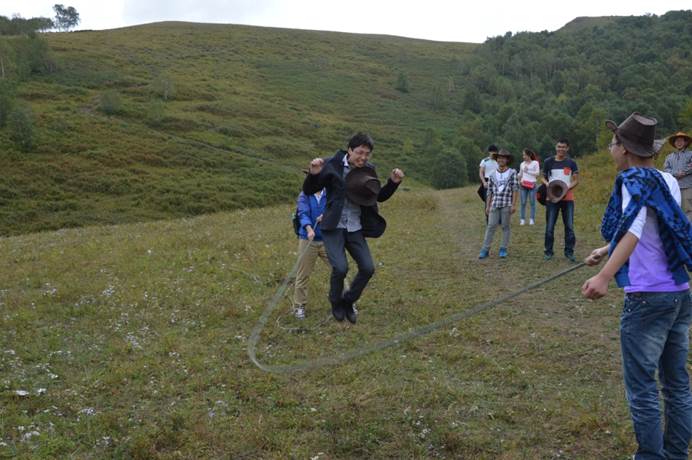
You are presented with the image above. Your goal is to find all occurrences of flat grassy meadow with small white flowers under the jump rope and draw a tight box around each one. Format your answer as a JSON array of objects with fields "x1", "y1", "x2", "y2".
[{"x1": 0, "y1": 150, "x2": 664, "y2": 460}]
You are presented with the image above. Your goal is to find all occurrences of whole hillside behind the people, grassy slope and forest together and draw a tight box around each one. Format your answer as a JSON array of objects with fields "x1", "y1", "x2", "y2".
[{"x1": 0, "y1": 11, "x2": 692, "y2": 235}]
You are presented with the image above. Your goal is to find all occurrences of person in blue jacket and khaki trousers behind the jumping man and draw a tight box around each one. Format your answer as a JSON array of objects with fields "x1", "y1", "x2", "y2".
[{"x1": 293, "y1": 189, "x2": 329, "y2": 319}]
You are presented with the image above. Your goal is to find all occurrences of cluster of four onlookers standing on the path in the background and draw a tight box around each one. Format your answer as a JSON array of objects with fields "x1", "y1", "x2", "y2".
[{"x1": 478, "y1": 139, "x2": 579, "y2": 262}]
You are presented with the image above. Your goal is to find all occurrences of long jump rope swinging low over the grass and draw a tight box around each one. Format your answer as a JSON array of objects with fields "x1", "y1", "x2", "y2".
[{"x1": 247, "y1": 237, "x2": 586, "y2": 374}]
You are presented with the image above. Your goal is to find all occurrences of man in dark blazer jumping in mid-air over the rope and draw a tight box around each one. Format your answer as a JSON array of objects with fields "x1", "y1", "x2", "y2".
[{"x1": 303, "y1": 133, "x2": 404, "y2": 324}]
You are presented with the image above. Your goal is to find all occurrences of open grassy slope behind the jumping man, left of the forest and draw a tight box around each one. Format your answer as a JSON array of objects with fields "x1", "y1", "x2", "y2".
[{"x1": 0, "y1": 22, "x2": 474, "y2": 235}]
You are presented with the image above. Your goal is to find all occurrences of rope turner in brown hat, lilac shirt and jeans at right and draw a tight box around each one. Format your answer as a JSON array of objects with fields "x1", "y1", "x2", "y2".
[{"x1": 581, "y1": 112, "x2": 692, "y2": 460}]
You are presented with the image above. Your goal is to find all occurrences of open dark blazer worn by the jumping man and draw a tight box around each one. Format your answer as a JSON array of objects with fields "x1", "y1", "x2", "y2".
[{"x1": 303, "y1": 150, "x2": 399, "y2": 238}]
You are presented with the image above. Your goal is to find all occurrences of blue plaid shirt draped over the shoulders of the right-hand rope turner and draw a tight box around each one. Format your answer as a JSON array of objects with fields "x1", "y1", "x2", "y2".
[{"x1": 601, "y1": 168, "x2": 692, "y2": 287}]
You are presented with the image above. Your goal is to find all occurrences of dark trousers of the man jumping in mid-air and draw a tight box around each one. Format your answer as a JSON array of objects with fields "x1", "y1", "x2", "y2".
[{"x1": 322, "y1": 228, "x2": 375, "y2": 305}]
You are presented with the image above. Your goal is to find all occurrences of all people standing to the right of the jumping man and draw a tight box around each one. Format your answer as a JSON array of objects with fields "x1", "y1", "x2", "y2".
[{"x1": 479, "y1": 124, "x2": 692, "y2": 460}]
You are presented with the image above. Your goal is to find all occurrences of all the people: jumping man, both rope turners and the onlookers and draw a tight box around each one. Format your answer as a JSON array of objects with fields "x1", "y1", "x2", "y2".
[{"x1": 294, "y1": 123, "x2": 692, "y2": 460}]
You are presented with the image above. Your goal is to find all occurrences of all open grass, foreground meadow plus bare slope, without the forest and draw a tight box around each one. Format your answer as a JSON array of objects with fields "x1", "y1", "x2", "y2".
[{"x1": 0, "y1": 17, "x2": 688, "y2": 460}]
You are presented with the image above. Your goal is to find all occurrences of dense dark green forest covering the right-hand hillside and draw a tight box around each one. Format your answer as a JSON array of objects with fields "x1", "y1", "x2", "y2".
[{"x1": 446, "y1": 11, "x2": 692, "y2": 160}]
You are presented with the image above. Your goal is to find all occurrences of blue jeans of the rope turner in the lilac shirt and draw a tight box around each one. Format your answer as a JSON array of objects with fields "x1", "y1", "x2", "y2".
[{"x1": 620, "y1": 291, "x2": 692, "y2": 460}]
